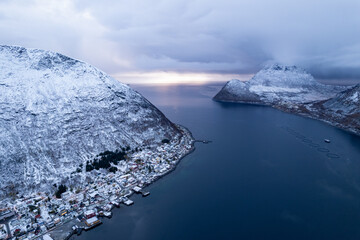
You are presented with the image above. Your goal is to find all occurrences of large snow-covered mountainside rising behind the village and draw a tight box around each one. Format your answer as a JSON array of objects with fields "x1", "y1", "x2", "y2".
[{"x1": 0, "y1": 46, "x2": 181, "y2": 196}]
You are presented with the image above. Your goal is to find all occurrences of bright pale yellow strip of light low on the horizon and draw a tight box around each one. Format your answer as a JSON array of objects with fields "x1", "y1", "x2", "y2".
[{"x1": 112, "y1": 71, "x2": 253, "y2": 85}]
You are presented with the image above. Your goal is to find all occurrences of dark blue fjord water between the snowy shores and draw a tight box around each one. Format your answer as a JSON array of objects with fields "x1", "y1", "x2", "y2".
[{"x1": 77, "y1": 83, "x2": 360, "y2": 240}]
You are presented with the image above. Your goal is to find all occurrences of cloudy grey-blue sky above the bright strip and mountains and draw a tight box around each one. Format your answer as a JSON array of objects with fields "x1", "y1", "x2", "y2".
[{"x1": 0, "y1": 0, "x2": 360, "y2": 82}]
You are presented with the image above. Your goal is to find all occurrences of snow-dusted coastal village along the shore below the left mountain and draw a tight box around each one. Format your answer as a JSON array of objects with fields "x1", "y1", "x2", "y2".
[{"x1": 0, "y1": 127, "x2": 194, "y2": 240}]
